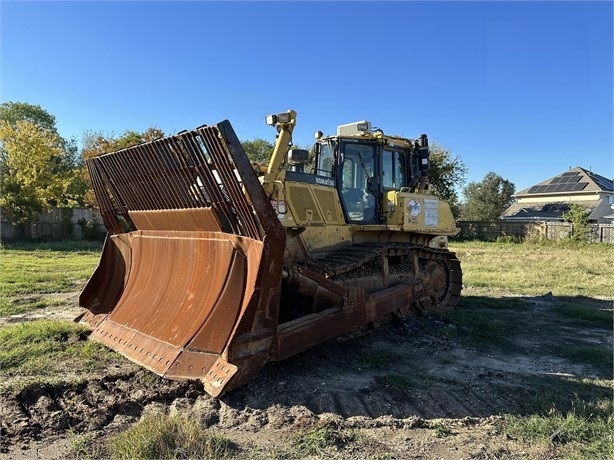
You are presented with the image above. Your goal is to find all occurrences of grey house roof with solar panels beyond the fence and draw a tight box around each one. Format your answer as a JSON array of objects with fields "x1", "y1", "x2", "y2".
[{"x1": 514, "y1": 166, "x2": 614, "y2": 197}]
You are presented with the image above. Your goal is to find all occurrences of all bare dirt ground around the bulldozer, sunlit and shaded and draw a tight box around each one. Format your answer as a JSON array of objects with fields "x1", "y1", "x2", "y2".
[{"x1": 0, "y1": 292, "x2": 612, "y2": 459}]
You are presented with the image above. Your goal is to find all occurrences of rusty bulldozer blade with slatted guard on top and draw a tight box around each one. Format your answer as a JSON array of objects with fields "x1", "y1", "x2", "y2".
[{"x1": 79, "y1": 120, "x2": 285, "y2": 396}]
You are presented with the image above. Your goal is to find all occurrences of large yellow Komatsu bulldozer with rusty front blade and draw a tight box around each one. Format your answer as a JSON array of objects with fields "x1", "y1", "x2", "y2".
[{"x1": 78, "y1": 110, "x2": 462, "y2": 397}]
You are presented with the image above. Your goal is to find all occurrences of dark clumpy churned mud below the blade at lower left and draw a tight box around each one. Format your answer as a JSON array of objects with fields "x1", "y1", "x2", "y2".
[{"x1": 0, "y1": 370, "x2": 204, "y2": 452}]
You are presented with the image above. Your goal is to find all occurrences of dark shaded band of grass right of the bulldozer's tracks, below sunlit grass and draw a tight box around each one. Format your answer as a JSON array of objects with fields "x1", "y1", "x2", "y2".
[{"x1": 430, "y1": 296, "x2": 614, "y2": 375}]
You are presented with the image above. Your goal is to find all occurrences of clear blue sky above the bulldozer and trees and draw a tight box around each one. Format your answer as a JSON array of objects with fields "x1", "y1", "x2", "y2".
[{"x1": 0, "y1": 1, "x2": 614, "y2": 191}]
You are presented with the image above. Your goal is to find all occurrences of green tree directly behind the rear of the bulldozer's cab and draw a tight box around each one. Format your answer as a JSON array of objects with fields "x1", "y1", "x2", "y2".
[{"x1": 429, "y1": 142, "x2": 467, "y2": 217}]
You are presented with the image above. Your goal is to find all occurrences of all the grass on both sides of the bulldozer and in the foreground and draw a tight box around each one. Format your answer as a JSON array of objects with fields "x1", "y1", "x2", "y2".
[{"x1": 0, "y1": 242, "x2": 614, "y2": 459}]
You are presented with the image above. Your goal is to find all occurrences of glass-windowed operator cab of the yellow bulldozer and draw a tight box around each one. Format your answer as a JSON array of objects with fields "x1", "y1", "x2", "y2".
[{"x1": 314, "y1": 121, "x2": 428, "y2": 224}]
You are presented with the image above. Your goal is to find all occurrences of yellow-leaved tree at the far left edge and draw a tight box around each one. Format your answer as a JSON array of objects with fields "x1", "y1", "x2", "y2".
[{"x1": 0, "y1": 120, "x2": 75, "y2": 231}]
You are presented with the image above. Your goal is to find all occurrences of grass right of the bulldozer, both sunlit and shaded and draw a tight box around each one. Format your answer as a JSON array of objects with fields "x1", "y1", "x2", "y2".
[{"x1": 431, "y1": 242, "x2": 614, "y2": 459}]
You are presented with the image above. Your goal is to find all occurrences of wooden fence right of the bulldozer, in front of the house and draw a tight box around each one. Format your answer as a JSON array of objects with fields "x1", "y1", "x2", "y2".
[{"x1": 454, "y1": 220, "x2": 614, "y2": 244}]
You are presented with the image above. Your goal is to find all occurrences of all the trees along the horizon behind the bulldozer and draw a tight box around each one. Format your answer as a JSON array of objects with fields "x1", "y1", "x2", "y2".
[{"x1": 0, "y1": 98, "x2": 515, "y2": 232}]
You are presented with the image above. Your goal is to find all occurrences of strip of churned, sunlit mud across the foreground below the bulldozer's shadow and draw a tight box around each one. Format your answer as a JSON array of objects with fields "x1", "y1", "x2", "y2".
[{"x1": 0, "y1": 371, "x2": 524, "y2": 459}]
